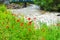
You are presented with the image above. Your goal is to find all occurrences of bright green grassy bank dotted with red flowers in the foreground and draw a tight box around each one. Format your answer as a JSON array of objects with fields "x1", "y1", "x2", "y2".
[{"x1": 0, "y1": 6, "x2": 60, "y2": 40}]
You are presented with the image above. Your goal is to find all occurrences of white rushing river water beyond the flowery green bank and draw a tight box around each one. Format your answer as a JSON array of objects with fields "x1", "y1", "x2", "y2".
[{"x1": 11, "y1": 4, "x2": 60, "y2": 25}]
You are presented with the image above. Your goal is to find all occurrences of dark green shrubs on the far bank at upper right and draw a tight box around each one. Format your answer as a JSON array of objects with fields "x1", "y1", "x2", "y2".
[{"x1": 35, "y1": 0, "x2": 60, "y2": 11}]
